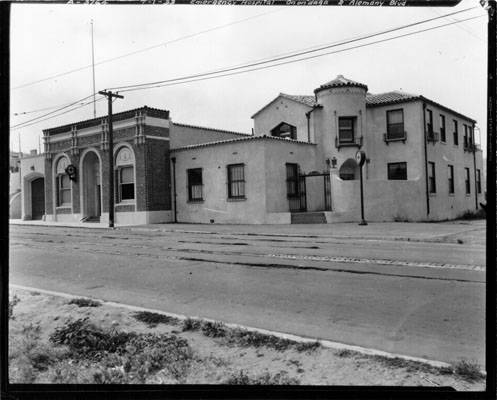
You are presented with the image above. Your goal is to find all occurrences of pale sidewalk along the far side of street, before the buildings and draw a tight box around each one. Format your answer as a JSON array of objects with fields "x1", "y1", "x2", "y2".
[{"x1": 10, "y1": 220, "x2": 486, "y2": 245}]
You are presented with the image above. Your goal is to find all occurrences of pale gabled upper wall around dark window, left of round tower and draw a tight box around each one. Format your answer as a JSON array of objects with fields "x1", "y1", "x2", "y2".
[{"x1": 253, "y1": 97, "x2": 314, "y2": 142}]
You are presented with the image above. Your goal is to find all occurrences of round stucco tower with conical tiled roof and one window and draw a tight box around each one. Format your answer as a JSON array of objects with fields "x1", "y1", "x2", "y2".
[{"x1": 314, "y1": 75, "x2": 368, "y2": 175}]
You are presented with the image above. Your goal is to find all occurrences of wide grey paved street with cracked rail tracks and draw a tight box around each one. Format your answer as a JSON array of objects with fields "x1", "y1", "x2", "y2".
[{"x1": 10, "y1": 221, "x2": 485, "y2": 364}]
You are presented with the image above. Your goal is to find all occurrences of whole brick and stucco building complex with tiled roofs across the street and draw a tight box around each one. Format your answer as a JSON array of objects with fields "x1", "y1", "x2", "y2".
[{"x1": 26, "y1": 76, "x2": 485, "y2": 224}]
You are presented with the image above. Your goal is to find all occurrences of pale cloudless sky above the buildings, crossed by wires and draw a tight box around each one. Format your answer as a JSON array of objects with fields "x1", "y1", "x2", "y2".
[{"x1": 10, "y1": 0, "x2": 488, "y2": 152}]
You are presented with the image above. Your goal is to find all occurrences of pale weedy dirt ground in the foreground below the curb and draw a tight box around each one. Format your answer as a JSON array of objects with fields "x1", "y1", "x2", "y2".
[{"x1": 9, "y1": 289, "x2": 485, "y2": 391}]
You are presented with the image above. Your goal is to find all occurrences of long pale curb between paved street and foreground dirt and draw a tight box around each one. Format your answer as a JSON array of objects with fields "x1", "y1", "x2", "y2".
[{"x1": 9, "y1": 284, "x2": 456, "y2": 373}]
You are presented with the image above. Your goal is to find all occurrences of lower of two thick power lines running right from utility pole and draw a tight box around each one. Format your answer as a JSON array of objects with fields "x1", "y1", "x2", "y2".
[{"x1": 117, "y1": 15, "x2": 486, "y2": 93}]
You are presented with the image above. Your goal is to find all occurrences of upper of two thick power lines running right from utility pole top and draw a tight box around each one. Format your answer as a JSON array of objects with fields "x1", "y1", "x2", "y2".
[{"x1": 109, "y1": 7, "x2": 477, "y2": 91}]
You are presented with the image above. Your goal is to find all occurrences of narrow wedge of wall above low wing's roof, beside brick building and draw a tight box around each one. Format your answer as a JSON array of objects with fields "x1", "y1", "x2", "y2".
[{"x1": 170, "y1": 123, "x2": 250, "y2": 149}]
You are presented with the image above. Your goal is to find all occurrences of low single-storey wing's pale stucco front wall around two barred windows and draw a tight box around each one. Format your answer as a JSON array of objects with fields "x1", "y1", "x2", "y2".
[{"x1": 172, "y1": 141, "x2": 266, "y2": 224}]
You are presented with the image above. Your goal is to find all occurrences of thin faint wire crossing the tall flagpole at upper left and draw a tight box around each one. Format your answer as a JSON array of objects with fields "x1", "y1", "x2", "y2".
[{"x1": 12, "y1": 7, "x2": 287, "y2": 90}]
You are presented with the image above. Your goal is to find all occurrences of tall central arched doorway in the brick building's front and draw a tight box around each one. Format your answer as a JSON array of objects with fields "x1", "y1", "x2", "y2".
[{"x1": 82, "y1": 151, "x2": 101, "y2": 221}]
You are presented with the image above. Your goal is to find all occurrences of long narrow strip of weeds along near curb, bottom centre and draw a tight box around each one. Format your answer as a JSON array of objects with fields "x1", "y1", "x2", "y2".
[{"x1": 182, "y1": 318, "x2": 321, "y2": 352}]
